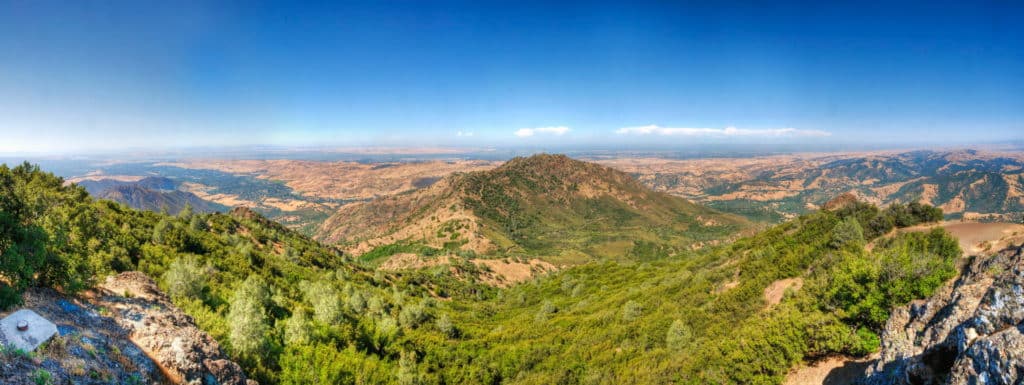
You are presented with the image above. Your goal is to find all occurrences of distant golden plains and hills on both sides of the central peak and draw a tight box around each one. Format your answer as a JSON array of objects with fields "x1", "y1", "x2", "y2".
[{"x1": 51, "y1": 148, "x2": 1024, "y2": 240}]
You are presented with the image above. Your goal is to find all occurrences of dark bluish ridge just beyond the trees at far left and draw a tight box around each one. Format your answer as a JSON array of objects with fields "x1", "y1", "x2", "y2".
[{"x1": 78, "y1": 176, "x2": 227, "y2": 214}]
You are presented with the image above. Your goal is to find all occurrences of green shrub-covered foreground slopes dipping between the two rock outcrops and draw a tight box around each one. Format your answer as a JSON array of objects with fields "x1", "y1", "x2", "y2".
[{"x1": 0, "y1": 159, "x2": 959, "y2": 384}]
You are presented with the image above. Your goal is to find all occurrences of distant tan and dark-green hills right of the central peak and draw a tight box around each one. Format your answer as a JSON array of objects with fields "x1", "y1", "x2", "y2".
[{"x1": 601, "y1": 149, "x2": 1024, "y2": 222}]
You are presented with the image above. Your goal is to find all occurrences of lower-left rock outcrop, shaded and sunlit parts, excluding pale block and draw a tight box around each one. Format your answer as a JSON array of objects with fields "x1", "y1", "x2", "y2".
[{"x1": 0, "y1": 272, "x2": 256, "y2": 385}]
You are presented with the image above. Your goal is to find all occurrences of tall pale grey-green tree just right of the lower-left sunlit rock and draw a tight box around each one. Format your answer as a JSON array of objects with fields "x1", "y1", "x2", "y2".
[{"x1": 227, "y1": 274, "x2": 269, "y2": 354}]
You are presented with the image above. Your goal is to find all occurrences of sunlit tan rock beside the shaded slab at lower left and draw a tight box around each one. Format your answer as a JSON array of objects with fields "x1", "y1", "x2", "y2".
[{"x1": 97, "y1": 271, "x2": 256, "y2": 385}]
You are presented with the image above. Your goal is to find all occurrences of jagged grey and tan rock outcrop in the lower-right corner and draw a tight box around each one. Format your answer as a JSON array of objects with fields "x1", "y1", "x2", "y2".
[{"x1": 863, "y1": 247, "x2": 1024, "y2": 385}]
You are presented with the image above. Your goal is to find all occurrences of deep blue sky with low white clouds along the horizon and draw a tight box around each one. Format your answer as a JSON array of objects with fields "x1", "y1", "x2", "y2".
[{"x1": 0, "y1": 0, "x2": 1024, "y2": 153}]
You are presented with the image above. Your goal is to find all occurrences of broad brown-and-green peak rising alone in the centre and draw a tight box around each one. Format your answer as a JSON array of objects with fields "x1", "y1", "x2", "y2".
[{"x1": 316, "y1": 155, "x2": 748, "y2": 263}]
